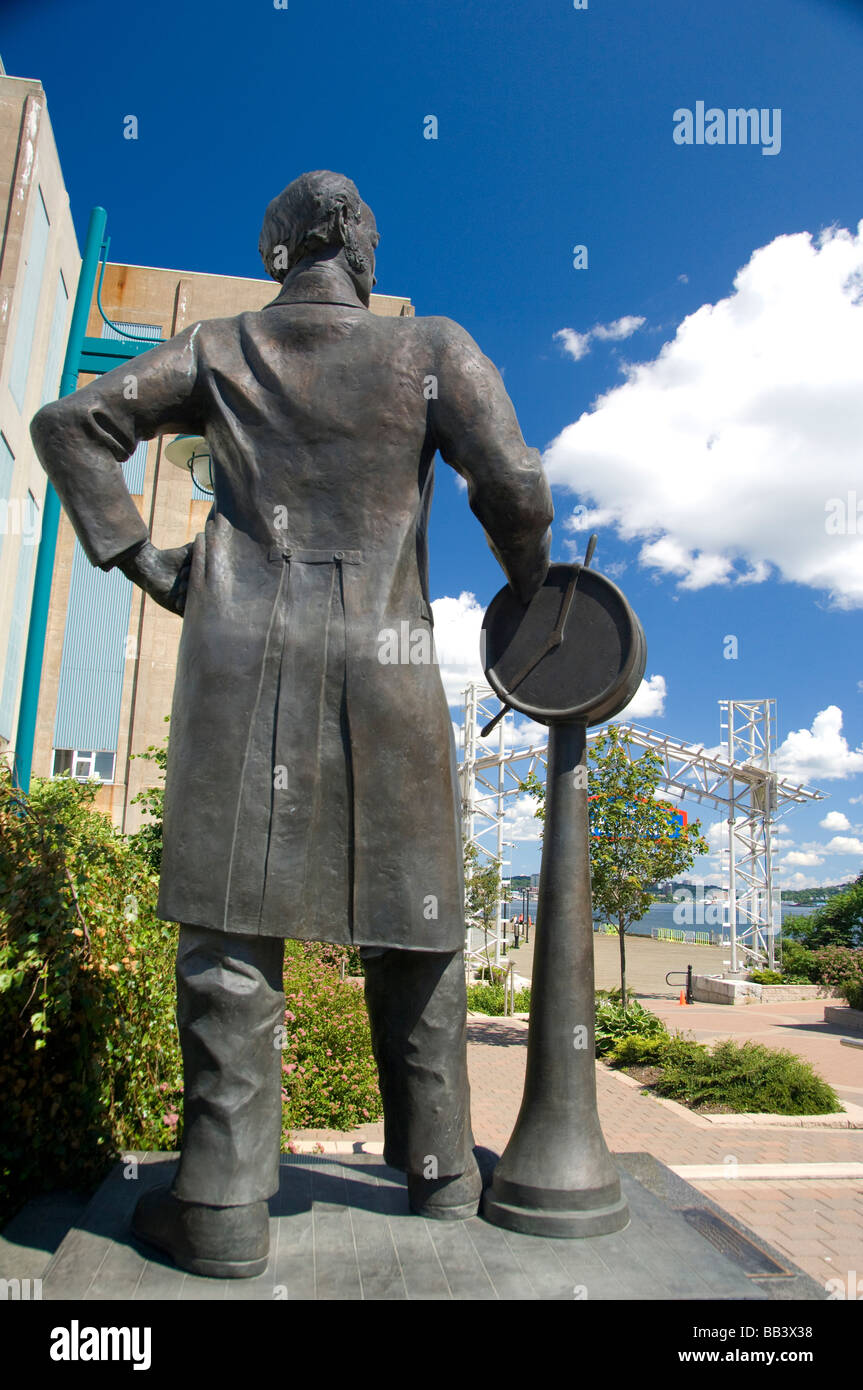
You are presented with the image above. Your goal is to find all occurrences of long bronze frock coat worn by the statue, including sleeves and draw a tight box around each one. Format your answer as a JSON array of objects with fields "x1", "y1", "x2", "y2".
[{"x1": 32, "y1": 300, "x2": 552, "y2": 951}]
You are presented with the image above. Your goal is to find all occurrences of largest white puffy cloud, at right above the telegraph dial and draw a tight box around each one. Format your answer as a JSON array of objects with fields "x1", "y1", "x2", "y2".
[{"x1": 545, "y1": 222, "x2": 863, "y2": 607}]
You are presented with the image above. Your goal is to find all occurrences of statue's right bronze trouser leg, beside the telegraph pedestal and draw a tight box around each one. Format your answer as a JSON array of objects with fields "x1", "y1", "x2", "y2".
[{"x1": 360, "y1": 948, "x2": 474, "y2": 1177}]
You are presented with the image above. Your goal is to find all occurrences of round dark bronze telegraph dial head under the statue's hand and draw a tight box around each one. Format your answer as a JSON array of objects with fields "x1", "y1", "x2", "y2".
[{"x1": 482, "y1": 564, "x2": 648, "y2": 724}]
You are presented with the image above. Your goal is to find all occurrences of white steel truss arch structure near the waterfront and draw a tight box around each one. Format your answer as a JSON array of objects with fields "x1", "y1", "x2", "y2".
[{"x1": 459, "y1": 684, "x2": 824, "y2": 972}]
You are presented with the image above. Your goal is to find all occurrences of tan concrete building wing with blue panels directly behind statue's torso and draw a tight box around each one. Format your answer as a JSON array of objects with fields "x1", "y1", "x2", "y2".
[{"x1": 33, "y1": 259, "x2": 413, "y2": 831}]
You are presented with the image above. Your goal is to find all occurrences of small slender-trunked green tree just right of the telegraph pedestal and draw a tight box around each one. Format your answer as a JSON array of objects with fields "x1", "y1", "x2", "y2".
[{"x1": 520, "y1": 724, "x2": 709, "y2": 1009}]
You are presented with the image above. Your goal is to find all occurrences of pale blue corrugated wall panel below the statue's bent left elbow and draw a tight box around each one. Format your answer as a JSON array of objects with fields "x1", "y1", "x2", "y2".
[{"x1": 54, "y1": 541, "x2": 132, "y2": 752}]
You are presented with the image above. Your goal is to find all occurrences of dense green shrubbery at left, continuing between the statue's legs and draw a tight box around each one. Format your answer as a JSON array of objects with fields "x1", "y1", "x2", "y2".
[{"x1": 0, "y1": 767, "x2": 381, "y2": 1220}]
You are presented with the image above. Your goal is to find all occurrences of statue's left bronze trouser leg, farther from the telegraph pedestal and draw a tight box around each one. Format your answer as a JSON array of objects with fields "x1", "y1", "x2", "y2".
[{"x1": 174, "y1": 926, "x2": 285, "y2": 1207}]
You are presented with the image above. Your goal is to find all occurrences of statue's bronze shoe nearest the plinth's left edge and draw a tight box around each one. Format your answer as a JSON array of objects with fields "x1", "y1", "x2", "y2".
[{"x1": 132, "y1": 1183, "x2": 270, "y2": 1279}]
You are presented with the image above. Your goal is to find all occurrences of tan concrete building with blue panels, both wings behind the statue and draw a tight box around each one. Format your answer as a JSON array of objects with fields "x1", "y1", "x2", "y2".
[{"x1": 0, "y1": 63, "x2": 413, "y2": 831}]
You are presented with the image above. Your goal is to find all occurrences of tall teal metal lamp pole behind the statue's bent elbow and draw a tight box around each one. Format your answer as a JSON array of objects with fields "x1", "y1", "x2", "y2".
[{"x1": 14, "y1": 207, "x2": 108, "y2": 792}]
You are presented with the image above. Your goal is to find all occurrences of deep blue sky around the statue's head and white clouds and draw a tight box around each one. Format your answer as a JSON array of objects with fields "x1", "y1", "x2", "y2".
[{"x1": 6, "y1": 0, "x2": 863, "y2": 885}]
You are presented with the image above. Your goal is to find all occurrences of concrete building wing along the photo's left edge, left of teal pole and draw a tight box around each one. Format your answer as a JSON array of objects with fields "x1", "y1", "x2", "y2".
[{"x1": 0, "y1": 64, "x2": 81, "y2": 751}]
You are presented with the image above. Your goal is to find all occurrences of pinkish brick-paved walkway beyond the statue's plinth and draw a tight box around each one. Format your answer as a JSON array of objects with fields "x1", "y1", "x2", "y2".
[{"x1": 295, "y1": 934, "x2": 863, "y2": 1298}]
